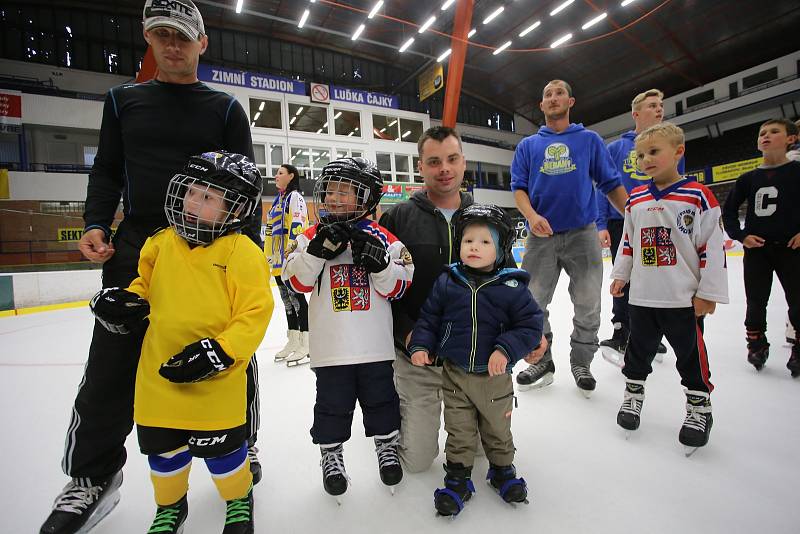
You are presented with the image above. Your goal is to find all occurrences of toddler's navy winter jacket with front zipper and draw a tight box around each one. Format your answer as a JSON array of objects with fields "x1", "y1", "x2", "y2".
[{"x1": 409, "y1": 264, "x2": 544, "y2": 373}]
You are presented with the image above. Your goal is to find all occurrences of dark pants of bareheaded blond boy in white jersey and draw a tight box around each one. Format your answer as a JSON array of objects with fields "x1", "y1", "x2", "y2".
[{"x1": 622, "y1": 304, "x2": 714, "y2": 393}]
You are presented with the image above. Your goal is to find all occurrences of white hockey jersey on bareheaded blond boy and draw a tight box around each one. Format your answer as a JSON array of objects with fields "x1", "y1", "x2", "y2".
[{"x1": 611, "y1": 179, "x2": 728, "y2": 308}]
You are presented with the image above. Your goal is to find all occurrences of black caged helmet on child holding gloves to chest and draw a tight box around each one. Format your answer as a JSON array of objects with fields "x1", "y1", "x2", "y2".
[{"x1": 314, "y1": 158, "x2": 383, "y2": 224}]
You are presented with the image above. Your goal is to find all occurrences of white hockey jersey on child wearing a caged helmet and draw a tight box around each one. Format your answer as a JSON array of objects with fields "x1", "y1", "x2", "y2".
[{"x1": 281, "y1": 220, "x2": 414, "y2": 367}]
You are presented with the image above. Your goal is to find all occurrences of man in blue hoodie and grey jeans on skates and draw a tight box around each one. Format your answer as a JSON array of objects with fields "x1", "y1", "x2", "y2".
[{"x1": 511, "y1": 80, "x2": 628, "y2": 397}]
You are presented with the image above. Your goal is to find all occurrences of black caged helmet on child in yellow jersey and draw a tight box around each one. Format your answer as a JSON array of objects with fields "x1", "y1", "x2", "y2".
[{"x1": 164, "y1": 151, "x2": 262, "y2": 245}]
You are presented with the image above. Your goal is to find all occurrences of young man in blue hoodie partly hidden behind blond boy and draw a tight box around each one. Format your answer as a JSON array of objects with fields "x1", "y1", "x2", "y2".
[{"x1": 597, "y1": 89, "x2": 684, "y2": 367}]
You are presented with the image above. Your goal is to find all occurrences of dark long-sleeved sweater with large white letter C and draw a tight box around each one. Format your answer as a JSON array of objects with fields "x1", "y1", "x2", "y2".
[{"x1": 722, "y1": 161, "x2": 800, "y2": 245}]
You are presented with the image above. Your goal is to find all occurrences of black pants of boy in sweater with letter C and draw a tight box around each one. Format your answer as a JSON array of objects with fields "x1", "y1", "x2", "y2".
[{"x1": 744, "y1": 245, "x2": 800, "y2": 338}]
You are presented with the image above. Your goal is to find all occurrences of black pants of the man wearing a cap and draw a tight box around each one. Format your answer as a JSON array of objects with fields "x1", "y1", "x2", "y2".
[{"x1": 61, "y1": 221, "x2": 259, "y2": 483}]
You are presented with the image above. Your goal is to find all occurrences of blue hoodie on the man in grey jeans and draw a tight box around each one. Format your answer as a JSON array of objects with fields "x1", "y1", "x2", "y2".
[{"x1": 511, "y1": 124, "x2": 620, "y2": 236}]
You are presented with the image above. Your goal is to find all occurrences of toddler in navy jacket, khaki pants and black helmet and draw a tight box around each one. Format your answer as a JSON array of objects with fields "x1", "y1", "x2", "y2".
[{"x1": 409, "y1": 204, "x2": 547, "y2": 516}]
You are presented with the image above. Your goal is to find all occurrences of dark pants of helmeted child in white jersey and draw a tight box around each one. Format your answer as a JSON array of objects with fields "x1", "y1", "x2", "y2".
[{"x1": 311, "y1": 361, "x2": 400, "y2": 445}]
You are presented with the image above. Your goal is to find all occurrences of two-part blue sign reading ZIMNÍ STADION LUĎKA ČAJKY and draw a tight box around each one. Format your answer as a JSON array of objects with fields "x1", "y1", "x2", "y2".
[{"x1": 197, "y1": 63, "x2": 400, "y2": 109}]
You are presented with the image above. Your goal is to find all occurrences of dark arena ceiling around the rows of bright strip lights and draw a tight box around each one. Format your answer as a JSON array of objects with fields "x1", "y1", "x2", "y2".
[{"x1": 39, "y1": 0, "x2": 800, "y2": 124}]
